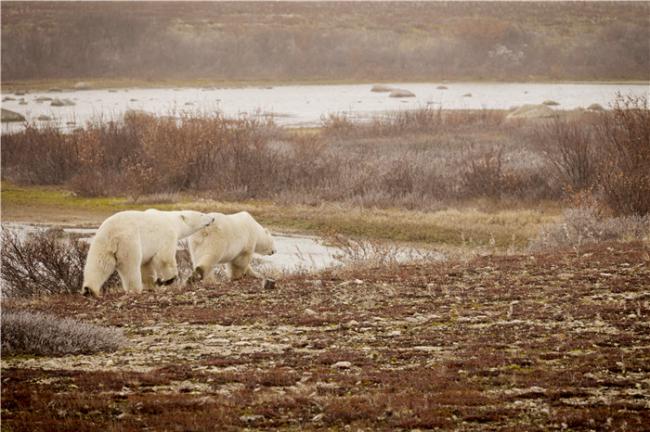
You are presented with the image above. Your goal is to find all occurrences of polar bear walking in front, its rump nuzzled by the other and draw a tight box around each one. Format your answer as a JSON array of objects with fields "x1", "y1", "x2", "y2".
[{"x1": 188, "y1": 212, "x2": 275, "y2": 282}]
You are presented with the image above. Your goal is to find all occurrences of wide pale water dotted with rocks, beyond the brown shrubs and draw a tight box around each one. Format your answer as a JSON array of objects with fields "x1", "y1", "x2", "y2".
[{"x1": 2, "y1": 83, "x2": 650, "y2": 132}]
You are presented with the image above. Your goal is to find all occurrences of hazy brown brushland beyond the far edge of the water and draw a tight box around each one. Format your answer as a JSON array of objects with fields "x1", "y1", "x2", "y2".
[{"x1": 2, "y1": 2, "x2": 650, "y2": 83}]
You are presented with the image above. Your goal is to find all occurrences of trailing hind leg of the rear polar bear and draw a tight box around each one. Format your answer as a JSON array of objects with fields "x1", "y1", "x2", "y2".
[{"x1": 81, "y1": 236, "x2": 117, "y2": 297}]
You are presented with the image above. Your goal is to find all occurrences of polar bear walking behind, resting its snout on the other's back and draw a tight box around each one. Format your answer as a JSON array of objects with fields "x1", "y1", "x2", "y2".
[{"x1": 82, "y1": 209, "x2": 214, "y2": 297}]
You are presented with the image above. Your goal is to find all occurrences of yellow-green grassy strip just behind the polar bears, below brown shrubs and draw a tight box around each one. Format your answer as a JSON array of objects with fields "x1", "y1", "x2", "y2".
[{"x1": 2, "y1": 182, "x2": 560, "y2": 251}]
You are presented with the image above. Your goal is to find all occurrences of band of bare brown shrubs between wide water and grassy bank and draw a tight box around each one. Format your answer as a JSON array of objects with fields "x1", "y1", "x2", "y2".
[{"x1": 2, "y1": 97, "x2": 650, "y2": 215}]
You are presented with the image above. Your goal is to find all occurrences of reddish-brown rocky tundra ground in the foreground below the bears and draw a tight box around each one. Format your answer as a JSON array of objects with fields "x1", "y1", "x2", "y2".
[{"x1": 2, "y1": 243, "x2": 650, "y2": 431}]
